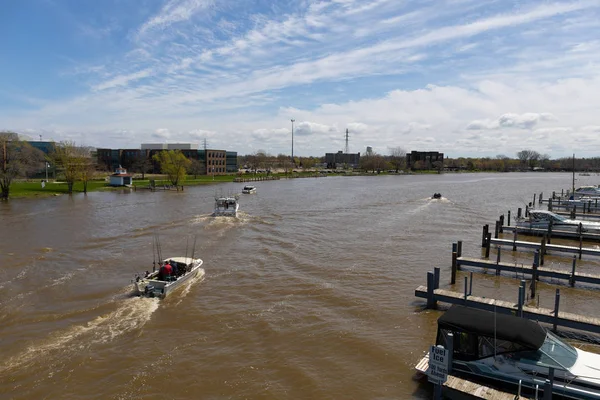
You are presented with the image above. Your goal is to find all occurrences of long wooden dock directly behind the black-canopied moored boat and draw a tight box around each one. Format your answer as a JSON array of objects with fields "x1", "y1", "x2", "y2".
[{"x1": 415, "y1": 284, "x2": 600, "y2": 334}]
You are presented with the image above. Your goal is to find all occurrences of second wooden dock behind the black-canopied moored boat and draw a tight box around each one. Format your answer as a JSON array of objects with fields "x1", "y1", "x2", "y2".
[{"x1": 456, "y1": 257, "x2": 600, "y2": 286}]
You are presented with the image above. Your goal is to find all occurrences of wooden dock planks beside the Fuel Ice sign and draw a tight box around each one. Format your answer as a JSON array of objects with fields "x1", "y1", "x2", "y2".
[{"x1": 415, "y1": 354, "x2": 529, "y2": 400}]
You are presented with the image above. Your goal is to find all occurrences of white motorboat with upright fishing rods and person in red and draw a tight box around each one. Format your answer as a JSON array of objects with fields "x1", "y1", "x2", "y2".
[{"x1": 133, "y1": 257, "x2": 204, "y2": 298}]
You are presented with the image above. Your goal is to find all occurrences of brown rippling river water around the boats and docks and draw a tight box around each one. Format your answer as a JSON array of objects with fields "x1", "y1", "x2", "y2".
[{"x1": 0, "y1": 173, "x2": 600, "y2": 399}]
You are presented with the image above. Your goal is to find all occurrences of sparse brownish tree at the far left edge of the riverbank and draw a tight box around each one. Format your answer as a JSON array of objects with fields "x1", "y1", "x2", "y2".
[{"x1": 0, "y1": 132, "x2": 44, "y2": 200}]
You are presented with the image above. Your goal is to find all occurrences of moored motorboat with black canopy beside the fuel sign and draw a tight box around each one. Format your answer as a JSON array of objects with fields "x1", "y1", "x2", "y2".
[{"x1": 436, "y1": 305, "x2": 600, "y2": 400}]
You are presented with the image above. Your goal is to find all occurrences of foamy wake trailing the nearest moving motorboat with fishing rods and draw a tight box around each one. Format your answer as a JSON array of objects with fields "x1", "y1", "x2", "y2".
[{"x1": 0, "y1": 297, "x2": 159, "y2": 376}]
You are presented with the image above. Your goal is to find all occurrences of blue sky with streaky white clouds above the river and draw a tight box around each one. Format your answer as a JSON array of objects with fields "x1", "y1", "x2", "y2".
[{"x1": 0, "y1": 0, "x2": 600, "y2": 158}]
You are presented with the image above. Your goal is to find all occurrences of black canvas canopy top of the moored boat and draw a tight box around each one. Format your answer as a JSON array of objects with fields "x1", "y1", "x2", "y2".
[{"x1": 438, "y1": 305, "x2": 546, "y2": 349}]
